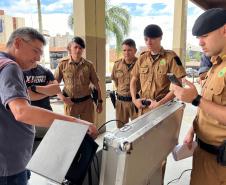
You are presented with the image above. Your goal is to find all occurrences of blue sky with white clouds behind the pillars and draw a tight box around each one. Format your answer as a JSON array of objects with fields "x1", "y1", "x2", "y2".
[{"x1": 0, "y1": 0, "x2": 202, "y2": 49}]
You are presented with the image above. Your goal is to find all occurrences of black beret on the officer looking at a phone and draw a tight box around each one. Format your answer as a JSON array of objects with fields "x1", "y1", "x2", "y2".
[{"x1": 192, "y1": 8, "x2": 226, "y2": 36}]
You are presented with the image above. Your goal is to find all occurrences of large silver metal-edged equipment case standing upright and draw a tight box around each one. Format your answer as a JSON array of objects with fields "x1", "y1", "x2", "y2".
[{"x1": 100, "y1": 101, "x2": 185, "y2": 185}]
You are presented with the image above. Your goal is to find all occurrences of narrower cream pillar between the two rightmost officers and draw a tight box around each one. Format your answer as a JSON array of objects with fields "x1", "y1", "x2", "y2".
[{"x1": 173, "y1": 0, "x2": 188, "y2": 66}]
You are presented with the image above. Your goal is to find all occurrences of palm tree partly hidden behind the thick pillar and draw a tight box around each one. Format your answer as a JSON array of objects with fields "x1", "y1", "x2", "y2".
[{"x1": 68, "y1": 1, "x2": 131, "y2": 53}]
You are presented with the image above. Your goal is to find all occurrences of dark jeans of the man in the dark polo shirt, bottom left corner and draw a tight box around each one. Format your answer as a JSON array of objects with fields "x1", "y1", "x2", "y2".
[{"x1": 0, "y1": 170, "x2": 30, "y2": 185}]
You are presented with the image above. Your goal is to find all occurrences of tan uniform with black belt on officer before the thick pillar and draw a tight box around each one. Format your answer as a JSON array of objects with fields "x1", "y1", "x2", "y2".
[{"x1": 54, "y1": 57, "x2": 99, "y2": 123}]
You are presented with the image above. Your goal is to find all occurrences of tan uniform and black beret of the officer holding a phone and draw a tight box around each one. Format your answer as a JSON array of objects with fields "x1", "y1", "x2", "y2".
[{"x1": 191, "y1": 8, "x2": 226, "y2": 185}]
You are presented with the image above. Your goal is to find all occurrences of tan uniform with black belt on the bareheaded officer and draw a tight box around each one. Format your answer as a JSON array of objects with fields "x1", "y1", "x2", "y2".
[{"x1": 111, "y1": 58, "x2": 140, "y2": 128}]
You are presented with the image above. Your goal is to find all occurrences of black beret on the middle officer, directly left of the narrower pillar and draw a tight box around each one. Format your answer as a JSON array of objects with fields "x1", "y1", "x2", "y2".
[{"x1": 144, "y1": 24, "x2": 163, "y2": 38}]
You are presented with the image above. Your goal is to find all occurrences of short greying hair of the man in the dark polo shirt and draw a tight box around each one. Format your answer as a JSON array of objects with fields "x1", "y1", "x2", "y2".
[{"x1": 6, "y1": 27, "x2": 46, "y2": 47}]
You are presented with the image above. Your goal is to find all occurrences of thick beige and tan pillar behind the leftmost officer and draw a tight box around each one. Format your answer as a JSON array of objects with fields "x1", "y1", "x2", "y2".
[{"x1": 73, "y1": 0, "x2": 106, "y2": 127}]
